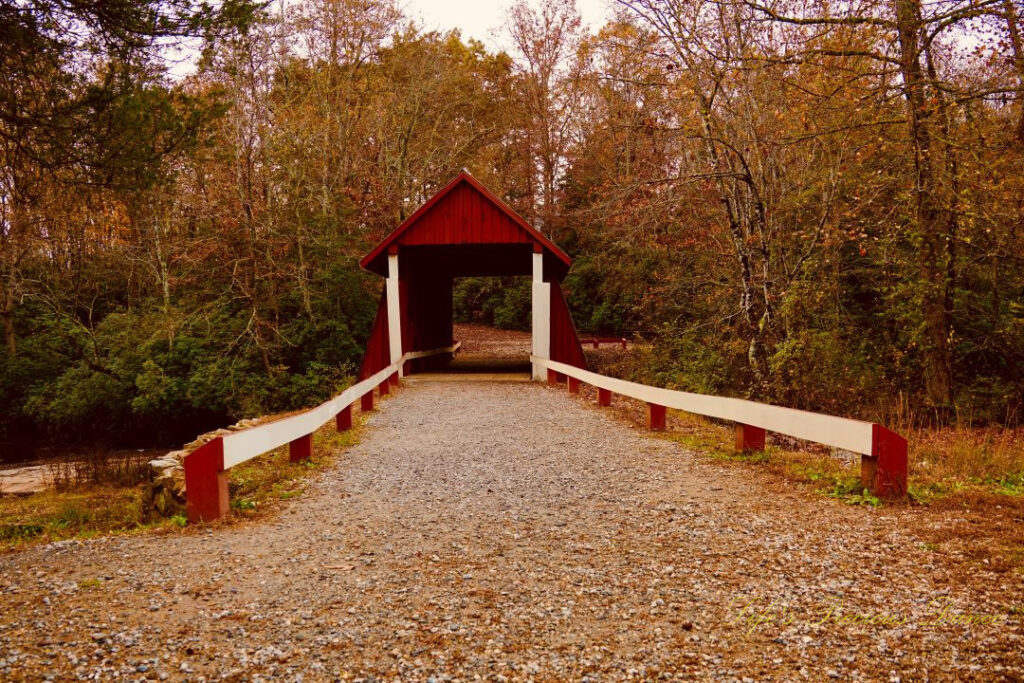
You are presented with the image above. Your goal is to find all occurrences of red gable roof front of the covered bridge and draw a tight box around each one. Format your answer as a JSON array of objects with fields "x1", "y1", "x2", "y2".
[{"x1": 359, "y1": 170, "x2": 572, "y2": 279}]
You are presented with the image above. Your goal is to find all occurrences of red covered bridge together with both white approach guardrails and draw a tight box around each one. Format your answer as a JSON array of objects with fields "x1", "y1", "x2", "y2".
[{"x1": 184, "y1": 171, "x2": 907, "y2": 522}]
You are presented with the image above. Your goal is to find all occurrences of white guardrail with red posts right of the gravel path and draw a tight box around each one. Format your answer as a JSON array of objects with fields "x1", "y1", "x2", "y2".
[{"x1": 530, "y1": 356, "x2": 907, "y2": 498}]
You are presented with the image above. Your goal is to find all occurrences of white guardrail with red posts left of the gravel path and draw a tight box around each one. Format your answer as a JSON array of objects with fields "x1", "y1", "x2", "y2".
[{"x1": 184, "y1": 342, "x2": 461, "y2": 522}]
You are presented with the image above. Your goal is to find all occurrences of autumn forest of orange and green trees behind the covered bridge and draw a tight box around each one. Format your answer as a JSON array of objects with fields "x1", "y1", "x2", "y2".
[{"x1": 0, "y1": 0, "x2": 1024, "y2": 460}]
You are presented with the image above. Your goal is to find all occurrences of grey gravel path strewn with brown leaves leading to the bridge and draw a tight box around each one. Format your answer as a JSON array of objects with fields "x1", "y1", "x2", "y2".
[{"x1": 0, "y1": 382, "x2": 1024, "y2": 681}]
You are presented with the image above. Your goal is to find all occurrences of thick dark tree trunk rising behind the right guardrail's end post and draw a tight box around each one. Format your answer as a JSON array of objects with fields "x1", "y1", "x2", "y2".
[{"x1": 895, "y1": 0, "x2": 953, "y2": 410}]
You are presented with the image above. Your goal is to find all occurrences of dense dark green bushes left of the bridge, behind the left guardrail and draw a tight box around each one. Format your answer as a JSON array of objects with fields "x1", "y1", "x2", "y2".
[{"x1": 0, "y1": 294, "x2": 372, "y2": 446}]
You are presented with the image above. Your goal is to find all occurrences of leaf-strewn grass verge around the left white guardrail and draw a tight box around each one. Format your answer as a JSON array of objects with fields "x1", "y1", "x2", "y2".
[{"x1": 0, "y1": 405, "x2": 370, "y2": 550}]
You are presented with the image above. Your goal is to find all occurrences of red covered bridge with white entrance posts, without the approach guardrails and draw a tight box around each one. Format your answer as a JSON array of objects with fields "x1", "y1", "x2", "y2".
[{"x1": 359, "y1": 171, "x2": 587, "y2": 379}]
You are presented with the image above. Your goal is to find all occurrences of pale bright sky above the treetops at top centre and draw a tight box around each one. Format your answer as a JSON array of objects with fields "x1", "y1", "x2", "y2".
[{"x1": 399, "y1": 0, "x2": 612, "y2": 51}]
